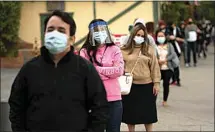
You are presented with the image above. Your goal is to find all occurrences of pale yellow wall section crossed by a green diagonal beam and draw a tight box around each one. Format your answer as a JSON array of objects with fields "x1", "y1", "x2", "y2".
[{"x1": 97, "y1": 2, "x2": 154, "y2": 34}]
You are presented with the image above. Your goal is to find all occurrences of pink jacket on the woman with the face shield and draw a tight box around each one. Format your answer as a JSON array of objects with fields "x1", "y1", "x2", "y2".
[{"x1": 80, "y1": 46, "x2": 124, "y2": 101}]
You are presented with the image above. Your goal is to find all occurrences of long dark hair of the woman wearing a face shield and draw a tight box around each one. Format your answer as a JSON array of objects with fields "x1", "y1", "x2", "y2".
[{"x1": 81, "y1": 19, "x2": 115, "y2": 66}]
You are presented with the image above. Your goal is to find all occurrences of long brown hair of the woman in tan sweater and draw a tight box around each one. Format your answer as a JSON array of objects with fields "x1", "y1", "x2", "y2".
[{"x1": 122, "y1": 24, "x2": 150, "y2": 56}]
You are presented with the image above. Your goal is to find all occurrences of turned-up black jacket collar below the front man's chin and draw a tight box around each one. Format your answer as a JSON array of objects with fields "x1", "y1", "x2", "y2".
[{"x1": 40, "y1": 46, "x2": 74, "y2": 64}]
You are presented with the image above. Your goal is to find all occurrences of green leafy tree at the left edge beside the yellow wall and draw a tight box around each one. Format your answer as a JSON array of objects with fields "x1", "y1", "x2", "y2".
[{"x1": 0, "y1": 1, "x2": 21, "y2": 56}]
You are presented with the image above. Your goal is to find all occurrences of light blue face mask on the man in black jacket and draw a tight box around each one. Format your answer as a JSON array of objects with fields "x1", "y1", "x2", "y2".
[{"x1": 45, "y1": 30, "x2": 68, "y2": 54}]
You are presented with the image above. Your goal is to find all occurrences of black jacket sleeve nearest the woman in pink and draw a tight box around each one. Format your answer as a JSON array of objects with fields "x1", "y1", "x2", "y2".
[{"x1": 86, "y1": 64, "x2": 109, "y2": 132}]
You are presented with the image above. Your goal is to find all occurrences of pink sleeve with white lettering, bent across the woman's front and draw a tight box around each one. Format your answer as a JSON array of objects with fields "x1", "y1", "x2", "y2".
[{"x1": 96, "y1": 48, "x2": 124, "y2": 78}]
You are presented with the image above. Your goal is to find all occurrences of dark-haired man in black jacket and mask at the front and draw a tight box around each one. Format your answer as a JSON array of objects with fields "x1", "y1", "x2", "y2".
[{"x1": 9, "y1": 11, "x2": 108, "y2": 132}]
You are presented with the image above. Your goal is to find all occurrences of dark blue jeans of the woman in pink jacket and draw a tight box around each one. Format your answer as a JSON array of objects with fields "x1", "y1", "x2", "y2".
[{"x1": 106, "y1": 100, "x2": 123, "y2": 132}]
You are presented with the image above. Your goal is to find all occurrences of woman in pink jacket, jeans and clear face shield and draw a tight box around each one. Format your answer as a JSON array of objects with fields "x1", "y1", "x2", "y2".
[{"x1": 80, "y1": 19, "x2": 124, "y2": 132}]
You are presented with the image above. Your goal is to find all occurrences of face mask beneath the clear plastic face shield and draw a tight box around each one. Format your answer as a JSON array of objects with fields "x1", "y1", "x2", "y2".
[{"x1": 93, "y1": 31, "x2": 108, "y2": 44}]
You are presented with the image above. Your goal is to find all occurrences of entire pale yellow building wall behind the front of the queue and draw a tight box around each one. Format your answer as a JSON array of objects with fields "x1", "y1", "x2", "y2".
[{"x1": 19, "y1": 2, "x2": 153, "y2": 46}]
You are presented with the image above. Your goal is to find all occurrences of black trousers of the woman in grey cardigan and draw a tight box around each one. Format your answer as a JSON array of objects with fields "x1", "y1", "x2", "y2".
[{"x1": 161, "y1": 70, "x2": 173, "y2": 101}]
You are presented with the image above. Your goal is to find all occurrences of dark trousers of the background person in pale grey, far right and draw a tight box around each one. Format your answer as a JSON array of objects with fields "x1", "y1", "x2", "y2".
[{"x1": 187, "y1": 42, "x2": 197, "y2": 64}]
